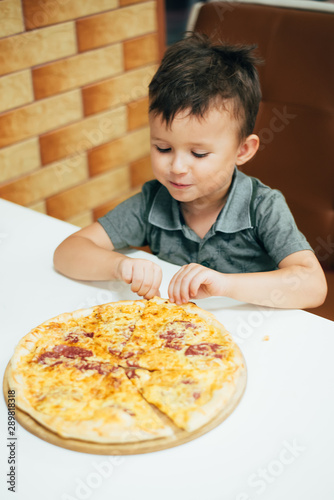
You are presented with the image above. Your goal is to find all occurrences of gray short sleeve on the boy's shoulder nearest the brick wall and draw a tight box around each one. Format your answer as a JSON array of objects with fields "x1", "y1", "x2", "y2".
[{"x1": 98, "y1": 181, "x2": 157, "y2": 249}]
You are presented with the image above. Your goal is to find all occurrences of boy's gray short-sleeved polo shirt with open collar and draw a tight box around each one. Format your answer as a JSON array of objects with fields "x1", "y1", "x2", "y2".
[{"x1": 98, "y1": 168, "x2": 312, "y2": 273}]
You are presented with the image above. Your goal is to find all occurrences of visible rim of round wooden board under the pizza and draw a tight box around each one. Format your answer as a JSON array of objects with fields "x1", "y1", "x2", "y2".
[{"x1": 3, "y1": 362, "x2": 247, "y2": 455}]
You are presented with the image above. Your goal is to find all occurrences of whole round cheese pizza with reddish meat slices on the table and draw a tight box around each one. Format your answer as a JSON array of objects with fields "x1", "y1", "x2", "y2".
[{"x1": 8, "y1": 297, "x2": 246, "y2": 443}]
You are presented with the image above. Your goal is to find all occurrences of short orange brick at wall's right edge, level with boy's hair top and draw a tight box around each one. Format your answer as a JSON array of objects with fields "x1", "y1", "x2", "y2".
[{"x1": 123, "y1": 33, "x2": 159, "y2": 71}]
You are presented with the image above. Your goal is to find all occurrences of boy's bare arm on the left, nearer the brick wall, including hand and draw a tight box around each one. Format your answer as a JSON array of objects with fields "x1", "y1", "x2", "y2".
[{"x1": 53, "y1": 222, "x2": 162, "y2": 299}]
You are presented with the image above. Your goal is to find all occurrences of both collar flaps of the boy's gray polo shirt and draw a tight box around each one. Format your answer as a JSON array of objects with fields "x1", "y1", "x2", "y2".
[{"x1": 148, "y1": 167, "x2": 253, "y2": 233}]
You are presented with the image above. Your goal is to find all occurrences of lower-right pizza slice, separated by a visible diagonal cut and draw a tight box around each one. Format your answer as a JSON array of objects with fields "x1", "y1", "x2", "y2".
[{"x1": 127, "y1": 368, "x2": 245, "y2": 432}]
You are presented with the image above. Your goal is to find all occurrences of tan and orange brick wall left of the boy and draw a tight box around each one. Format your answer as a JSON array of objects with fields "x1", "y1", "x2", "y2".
[{"x1": 0, "y1": 0, "x2": 163, "y2": 227}]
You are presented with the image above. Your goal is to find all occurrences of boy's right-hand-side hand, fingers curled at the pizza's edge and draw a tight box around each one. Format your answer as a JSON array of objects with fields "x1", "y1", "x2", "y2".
[{"x1": 168, "y1": 264, "x2": 223, "y2": 304}]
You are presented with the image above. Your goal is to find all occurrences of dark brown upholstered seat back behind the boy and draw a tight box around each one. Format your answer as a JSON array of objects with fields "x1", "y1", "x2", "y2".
[{"x1": 194, "y1": 2, "x2": 334, "y2": 320}]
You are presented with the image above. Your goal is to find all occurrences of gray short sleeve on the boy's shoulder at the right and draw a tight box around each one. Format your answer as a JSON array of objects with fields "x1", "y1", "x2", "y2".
[{"x1": 253, "y1": 185, "x2": 313, "y2": 265}]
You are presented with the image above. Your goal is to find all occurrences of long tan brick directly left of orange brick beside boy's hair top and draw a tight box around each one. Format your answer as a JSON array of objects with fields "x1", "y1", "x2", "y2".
[{"x1": 32, "y1": 44, "x2": 123, "y2": 99}]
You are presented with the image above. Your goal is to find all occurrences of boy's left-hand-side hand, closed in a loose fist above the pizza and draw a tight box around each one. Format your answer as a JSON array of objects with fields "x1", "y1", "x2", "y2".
[{"x1": 117, "y1": 257, "x2": 162, "y2": 299}]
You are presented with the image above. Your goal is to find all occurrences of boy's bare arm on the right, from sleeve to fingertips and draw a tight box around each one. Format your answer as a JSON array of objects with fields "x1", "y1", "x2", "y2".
[{"x1": 168, "y1": 250, "x2": 327, "y2": 309}]
